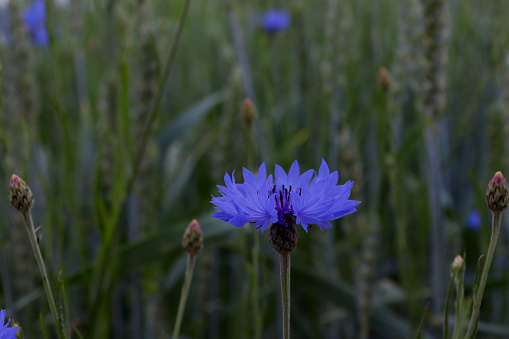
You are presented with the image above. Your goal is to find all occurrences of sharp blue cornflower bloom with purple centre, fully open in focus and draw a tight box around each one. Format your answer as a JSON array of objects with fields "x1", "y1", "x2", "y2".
[{"x1": 211, "y1": 159, "x2": 360, "y2": 232}]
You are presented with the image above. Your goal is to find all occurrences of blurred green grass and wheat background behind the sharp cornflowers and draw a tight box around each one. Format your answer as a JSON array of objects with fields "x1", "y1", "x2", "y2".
[{"x1": 0, "y1": 0, "x2": 509, "y2": 339}]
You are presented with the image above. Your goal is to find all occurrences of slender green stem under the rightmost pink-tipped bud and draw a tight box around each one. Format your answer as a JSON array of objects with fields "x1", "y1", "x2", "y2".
[{"x1": 465, "y1": 212, "x2": 502, "y2": 339}]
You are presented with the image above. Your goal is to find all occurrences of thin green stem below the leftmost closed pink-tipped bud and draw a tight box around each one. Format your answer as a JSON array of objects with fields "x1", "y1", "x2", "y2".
[{"x1": 22, "y1": 211, "x2": 65, "y2": 339}]
